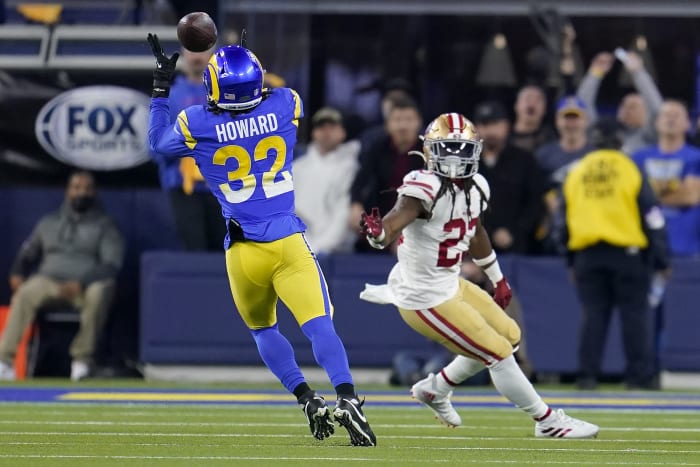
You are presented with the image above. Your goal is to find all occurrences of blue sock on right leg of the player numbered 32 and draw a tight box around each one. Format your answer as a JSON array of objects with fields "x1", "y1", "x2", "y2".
[{"x1": 301, "y1": 315, "x2": 352, "y2": 387}]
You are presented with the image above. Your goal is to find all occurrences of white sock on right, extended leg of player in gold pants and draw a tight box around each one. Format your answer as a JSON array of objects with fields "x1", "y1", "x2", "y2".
[{"x1": 489, "y1": 355, "x2": 551, "y2": 421}]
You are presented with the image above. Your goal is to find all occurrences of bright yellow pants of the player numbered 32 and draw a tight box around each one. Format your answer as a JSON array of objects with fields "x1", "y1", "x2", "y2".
[{"x1": 226, "y1": 234, "x2": 333, "y2": 329}]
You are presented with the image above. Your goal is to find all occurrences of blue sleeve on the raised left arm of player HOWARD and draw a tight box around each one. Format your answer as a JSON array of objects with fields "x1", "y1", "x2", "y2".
[{"x1": 148, "y1": 97, "x2": 191, "y2": 158}]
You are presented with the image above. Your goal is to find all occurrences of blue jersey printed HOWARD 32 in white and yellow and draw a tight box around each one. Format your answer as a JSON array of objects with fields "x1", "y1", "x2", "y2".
[{"x1": 148, "y1": 88, "x2": 306, "y2": 248}]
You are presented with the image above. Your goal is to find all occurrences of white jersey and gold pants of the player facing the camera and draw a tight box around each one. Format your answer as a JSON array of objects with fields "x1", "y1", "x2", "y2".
[{"x1": 361, "y1": 170, "x2": 520, "y2": 365}]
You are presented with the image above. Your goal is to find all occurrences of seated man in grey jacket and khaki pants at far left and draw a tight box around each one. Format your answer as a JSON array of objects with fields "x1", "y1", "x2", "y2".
[{"x1": 0, "y1": 171, "x2": 124, "y2": 381}]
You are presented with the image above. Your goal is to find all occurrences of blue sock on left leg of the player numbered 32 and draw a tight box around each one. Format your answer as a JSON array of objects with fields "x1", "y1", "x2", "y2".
[{"x1": 250, "y1": 324, "x2": 305, "y2": 393}]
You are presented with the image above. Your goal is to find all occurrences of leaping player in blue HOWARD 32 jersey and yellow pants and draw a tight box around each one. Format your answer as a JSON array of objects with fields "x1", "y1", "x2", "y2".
[{"x1": 148, "y1": 34, "x2": 376, "y2": 446}]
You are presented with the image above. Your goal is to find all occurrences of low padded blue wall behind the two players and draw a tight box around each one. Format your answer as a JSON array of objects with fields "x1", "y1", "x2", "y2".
[{"x1": 140, "y1": 252, "x2": 700, "y2": 374}]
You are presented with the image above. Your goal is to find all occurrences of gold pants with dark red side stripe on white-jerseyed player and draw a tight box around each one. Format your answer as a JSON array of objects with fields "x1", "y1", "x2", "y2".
[{"x1": 399, "y1": 279, "x2": 520, "y2": 365}]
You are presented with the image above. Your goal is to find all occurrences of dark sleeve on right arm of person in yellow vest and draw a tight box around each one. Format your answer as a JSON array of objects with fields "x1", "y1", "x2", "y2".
[{"x1": 637, "y1": 177, "x2": 670, "y2": 270}]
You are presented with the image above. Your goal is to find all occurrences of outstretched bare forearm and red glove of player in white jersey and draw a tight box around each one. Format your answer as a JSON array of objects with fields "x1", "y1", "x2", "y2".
[{"x1": 360, "y1": 196, "x2": 427, "y2": 249}]
